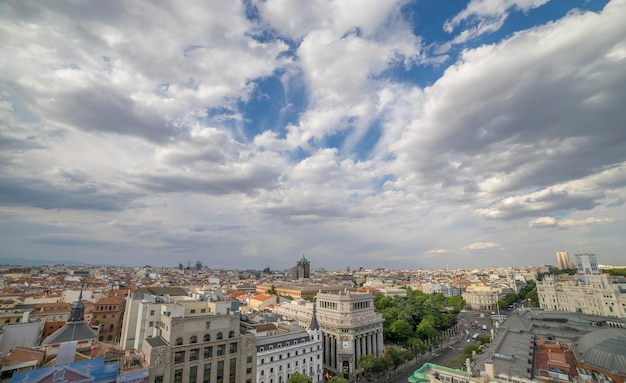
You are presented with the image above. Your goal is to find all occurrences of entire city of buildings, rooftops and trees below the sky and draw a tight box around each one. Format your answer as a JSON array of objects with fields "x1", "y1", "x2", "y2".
[{"x1": 0, "y1": 252, "x2": 626, "y2": 383}]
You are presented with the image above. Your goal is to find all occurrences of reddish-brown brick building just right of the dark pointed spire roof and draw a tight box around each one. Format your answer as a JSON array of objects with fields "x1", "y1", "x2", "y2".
[{"x1": 92, "y1": 297, "x2": 126, "y2": 343}]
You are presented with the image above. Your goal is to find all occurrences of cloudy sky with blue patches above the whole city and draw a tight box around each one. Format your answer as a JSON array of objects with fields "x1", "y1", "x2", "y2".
[{"x1": 0, "y1": 0, "x2": 626, "y2": 270}]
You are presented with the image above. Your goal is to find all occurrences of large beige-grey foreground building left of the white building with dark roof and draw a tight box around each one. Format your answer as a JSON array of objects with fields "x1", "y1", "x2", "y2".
[{"x1": 141, "y1": 313, "x2": 256, "y2": 383}]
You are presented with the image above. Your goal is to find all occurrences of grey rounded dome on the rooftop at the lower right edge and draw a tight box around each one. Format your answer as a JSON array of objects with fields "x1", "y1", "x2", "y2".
[{"x1": 576, "y1": 328, "x2": 626, "y2": 375}]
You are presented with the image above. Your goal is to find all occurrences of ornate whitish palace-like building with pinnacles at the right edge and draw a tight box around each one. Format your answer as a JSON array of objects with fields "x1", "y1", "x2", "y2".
[{"x1": 537, "y1": 274, "x2": 626, "y2": 318}]
